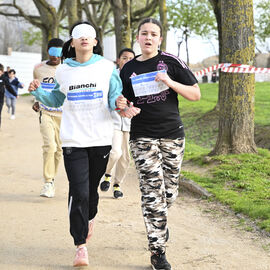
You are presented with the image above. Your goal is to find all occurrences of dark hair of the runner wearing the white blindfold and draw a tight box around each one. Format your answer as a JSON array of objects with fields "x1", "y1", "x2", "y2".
[{"x1": 62, "y1": 21, "x2": 103, "y2": 60}]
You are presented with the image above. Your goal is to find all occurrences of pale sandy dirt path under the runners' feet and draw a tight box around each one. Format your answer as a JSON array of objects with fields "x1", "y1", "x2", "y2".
[{"x1": 0, "y1": 97, "x2": 270, "y2": 270}]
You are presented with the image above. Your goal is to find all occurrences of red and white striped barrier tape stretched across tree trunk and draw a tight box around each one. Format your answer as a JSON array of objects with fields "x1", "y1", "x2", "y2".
[{"x1": 194, "y1": 63, "x2": 270, "y2": 77}]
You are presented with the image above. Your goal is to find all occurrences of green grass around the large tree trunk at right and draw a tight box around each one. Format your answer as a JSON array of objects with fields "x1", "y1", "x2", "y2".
[{"x1": 180, "y1": 82, "x2": 270, "y2": 232}]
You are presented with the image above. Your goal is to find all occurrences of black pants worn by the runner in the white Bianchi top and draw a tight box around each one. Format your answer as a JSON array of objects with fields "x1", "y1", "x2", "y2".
[{"x1": 63, "y1": 145, "x2": 111, "y2": 245}]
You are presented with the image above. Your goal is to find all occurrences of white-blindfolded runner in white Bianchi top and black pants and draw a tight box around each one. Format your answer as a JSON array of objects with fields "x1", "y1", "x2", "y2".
[{"x1": 29, "y1": 22, "x2": 131, "y2": 266}]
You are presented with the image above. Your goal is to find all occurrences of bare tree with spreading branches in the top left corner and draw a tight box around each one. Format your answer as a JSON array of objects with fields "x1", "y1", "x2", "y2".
[{"x1": 0, "y1": 0, "x2": 66, "y2": 59}]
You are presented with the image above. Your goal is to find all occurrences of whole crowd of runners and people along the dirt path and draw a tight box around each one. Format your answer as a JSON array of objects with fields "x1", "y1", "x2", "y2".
[{"x1": 0, "y1": 18, "x2": 200, "y2": 270}]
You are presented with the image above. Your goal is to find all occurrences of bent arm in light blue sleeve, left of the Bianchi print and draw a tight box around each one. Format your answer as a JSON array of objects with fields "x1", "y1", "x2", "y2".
[{"x1": 28, "y1": 80, "x2": 66, "y2": 108}]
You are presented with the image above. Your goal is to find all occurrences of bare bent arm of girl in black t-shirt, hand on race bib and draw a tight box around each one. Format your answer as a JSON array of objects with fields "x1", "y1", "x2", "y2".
[{"x1": 155, "y1": 72, "x2": 201, "y2": 101}]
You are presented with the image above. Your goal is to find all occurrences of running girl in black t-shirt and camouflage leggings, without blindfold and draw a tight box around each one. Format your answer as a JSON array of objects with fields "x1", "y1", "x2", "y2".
[{"x1": 120, "y1": 18, "x2": 200, "y2": 270}]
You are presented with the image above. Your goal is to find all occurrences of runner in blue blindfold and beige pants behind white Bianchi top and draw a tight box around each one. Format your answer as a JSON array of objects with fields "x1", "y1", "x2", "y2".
[{"x1": 32, "y1": 38, "x2": 64, "y2": 198}]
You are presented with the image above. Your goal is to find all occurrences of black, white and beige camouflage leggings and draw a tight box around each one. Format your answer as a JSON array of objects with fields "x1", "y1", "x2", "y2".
[{"x1": 130, "y1": 138, "x2": 185, "y2": 252}]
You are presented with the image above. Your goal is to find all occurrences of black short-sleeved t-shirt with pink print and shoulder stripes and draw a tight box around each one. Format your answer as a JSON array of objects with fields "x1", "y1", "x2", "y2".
[{"x1": 120, "y1": 51, "x2": 198, "y2": 140}]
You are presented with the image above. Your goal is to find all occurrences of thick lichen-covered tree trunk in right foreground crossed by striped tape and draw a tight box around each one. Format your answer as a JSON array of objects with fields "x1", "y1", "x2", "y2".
[{"x1": 210, "y1": 0, "x2": 256, "y2": 155}]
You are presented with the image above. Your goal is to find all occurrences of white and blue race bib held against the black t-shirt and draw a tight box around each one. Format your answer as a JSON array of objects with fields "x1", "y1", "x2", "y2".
[{"x1": 131, "y1": 70, "x2": 169, "y2": 97}]
